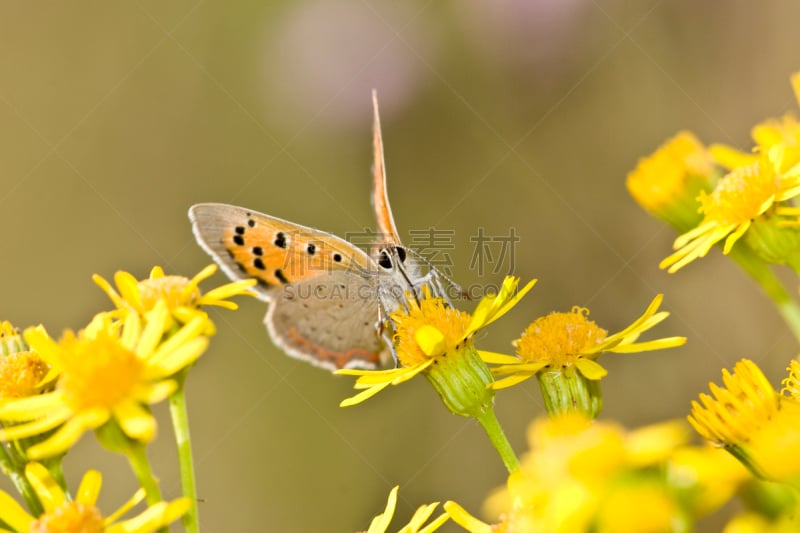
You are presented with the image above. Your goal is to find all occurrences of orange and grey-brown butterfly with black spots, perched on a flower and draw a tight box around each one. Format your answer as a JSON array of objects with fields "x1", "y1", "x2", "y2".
[{"x1": 189, "y1": 91, "x2": 450, "y2": 371}]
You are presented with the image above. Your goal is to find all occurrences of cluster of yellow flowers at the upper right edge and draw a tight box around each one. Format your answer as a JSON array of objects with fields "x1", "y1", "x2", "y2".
[{"x1": 628, "y1": 74, "x2": 800, "y2": 273}]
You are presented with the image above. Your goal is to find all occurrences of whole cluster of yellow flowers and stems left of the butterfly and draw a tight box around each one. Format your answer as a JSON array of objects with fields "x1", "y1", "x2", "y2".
[{"x1": 0, "y1": 266, "x2": 254, "y2": 533}]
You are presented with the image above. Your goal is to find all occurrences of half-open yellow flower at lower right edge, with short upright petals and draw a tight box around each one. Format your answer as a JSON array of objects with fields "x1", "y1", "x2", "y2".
[{"x1": 689, "y1": 359, "x2": 800, "y2": 483}]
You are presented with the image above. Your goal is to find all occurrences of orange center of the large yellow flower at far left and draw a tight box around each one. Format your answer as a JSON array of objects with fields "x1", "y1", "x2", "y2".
[{"x1": 58, "y1": 332, "x2": 144, "y2": 410}]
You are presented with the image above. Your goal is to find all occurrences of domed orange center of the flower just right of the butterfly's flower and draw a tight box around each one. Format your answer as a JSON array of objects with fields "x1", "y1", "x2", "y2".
[{"x1": 515, "y1": 307, "x2": 608, "y2": 367}]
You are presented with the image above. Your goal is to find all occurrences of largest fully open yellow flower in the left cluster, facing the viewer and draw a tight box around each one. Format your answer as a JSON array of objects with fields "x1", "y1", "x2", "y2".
[{"x1": 0, "y1": 301, "x2": 208, "y2": 459}]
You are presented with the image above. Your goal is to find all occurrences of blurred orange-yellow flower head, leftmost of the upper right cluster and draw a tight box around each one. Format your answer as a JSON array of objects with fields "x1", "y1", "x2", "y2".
[{"x1": 626, "y1": 131, "x2": 717, "y2": 231}]
